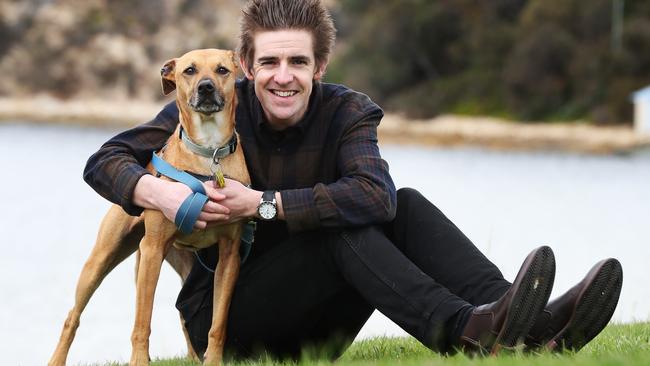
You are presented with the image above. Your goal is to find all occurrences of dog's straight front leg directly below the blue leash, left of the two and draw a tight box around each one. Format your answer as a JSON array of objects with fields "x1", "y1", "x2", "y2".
[{"x1": 129, "y1": 211, "x2": 176, "y2": 366}]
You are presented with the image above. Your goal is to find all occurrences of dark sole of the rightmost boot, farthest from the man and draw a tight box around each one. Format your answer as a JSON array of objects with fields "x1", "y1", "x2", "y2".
[{"x1": 547, "y1": 258, "x2": 623, "y2": 351}]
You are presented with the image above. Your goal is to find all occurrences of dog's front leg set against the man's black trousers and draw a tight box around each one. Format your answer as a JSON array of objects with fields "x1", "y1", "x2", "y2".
[{"x1": 203, "y1": 237, "x2": 240, "y2": 366}]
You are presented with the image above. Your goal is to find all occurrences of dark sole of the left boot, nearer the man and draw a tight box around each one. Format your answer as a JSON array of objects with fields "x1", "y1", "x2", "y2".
[{"x1": 491, "y1": 246, "x2": 555, "y2": 354}]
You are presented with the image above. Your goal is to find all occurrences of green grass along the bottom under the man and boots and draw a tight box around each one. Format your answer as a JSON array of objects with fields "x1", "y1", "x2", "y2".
[{"x1": 96, "y1": 323, "x2": 650, "y2": 366}]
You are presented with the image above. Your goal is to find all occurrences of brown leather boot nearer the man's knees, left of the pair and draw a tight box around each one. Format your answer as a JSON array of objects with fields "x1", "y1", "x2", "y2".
[{"x1": 460, "y1": 246, "x2": 555, "y2": 354}]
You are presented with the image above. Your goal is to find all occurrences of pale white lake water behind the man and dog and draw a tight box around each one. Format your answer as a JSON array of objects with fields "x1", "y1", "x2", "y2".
[{"x1": 0, "y1": 123, "x2": 650, "y2": 365}]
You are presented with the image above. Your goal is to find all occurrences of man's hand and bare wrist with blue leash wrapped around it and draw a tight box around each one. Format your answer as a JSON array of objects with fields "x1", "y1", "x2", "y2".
[{"x1": 133, "y1": 174, "x2": 230, "y2": 229}]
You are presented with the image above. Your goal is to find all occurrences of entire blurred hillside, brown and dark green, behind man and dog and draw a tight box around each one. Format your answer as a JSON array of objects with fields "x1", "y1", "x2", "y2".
[{"x1": 0, "y1": 0, "x2": 650, "y2": 126}]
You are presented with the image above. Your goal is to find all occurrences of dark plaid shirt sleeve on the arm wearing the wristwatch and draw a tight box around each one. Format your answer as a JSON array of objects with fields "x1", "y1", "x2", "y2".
[{"x1": 280, "y1": 118, "x2": 397, "y2": 232}]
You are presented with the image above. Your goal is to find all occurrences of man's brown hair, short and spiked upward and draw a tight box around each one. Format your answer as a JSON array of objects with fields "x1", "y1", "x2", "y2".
[{"x1": 238, "y1": 0, "x2": 336, "y2": 72}]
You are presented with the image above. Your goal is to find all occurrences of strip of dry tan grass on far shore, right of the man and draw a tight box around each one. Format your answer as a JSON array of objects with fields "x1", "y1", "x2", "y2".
[{"x1": 379, "y1": 115, "x2": 650, "y2": 154}]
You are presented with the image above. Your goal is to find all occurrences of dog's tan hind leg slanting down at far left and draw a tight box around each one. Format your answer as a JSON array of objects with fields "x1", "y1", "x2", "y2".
[{"x1": 48, "y1": 206, "x2": 144, "y2": 366}]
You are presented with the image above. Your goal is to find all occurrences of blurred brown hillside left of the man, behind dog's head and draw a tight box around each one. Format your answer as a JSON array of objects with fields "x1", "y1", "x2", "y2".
[{"x1": 0, "y1": 0, "x2": 241, "y2": 100}]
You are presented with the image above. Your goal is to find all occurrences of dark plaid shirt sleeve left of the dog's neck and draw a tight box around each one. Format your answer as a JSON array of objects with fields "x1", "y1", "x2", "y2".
[{"x1": 83, "y1": 102, "x2": 178, "y2": 216}]
